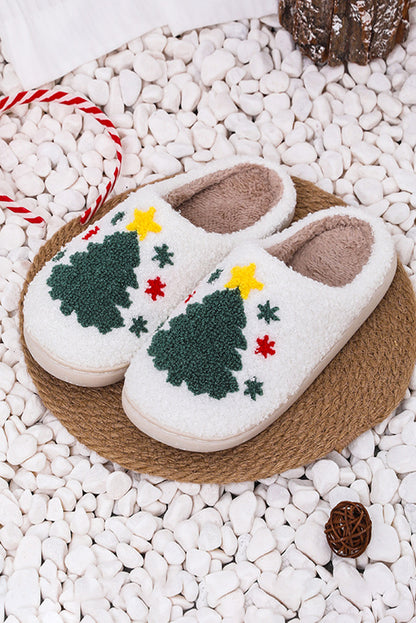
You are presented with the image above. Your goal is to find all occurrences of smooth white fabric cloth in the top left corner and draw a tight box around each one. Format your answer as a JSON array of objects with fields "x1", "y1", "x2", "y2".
[{"x1": 0, "y1": 0, "x2": 277, "y2": 89}]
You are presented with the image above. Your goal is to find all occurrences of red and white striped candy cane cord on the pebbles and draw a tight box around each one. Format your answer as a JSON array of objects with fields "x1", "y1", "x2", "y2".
[{"x1": 0, "y1": 89, "x2": 122, "y2": 223}]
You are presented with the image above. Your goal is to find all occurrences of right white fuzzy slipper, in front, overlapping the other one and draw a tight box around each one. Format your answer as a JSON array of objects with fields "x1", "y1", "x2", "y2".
[{"x1": 123, "y1": 208, "x2": 396, "y2": 452}]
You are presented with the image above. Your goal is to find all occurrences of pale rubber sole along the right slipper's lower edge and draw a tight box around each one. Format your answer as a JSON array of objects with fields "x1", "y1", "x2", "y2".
[{"x1": 122, "y1": 259, "x2": 397, "y2": 452}]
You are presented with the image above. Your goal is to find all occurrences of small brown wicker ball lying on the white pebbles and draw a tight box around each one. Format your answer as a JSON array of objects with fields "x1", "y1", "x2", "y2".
[{"x1": 325, "y1": 502, "x2": 371, "y2": 558}]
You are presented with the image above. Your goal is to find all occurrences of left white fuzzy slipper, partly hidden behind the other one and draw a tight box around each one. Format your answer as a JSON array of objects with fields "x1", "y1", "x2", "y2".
[{"x1": 24, "y1": 157, "x2": 296, "y2": 386}]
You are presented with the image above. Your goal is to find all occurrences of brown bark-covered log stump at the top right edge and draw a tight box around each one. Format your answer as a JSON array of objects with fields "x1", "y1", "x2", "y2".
[{"x1": 279, "y1": 0, "x2": 410, "y2": 65}]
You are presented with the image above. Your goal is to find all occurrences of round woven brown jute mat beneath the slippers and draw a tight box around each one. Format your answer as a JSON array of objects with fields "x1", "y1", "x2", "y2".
[{"x1": 20, "y1": 178, "x2": 416, "y2": 483}]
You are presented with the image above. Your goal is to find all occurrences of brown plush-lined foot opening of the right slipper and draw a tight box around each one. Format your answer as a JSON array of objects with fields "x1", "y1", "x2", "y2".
[{"x1": 268, "y1": 215, "x2": 374, "y2": 287}]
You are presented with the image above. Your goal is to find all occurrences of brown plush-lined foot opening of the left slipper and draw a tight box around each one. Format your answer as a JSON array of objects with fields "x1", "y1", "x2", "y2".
[{"x1": 166, "y1": 163, "x2": 283, "y2": 234}]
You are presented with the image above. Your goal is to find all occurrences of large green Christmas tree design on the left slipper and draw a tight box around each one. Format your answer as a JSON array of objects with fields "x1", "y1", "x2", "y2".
[{"x1": 47, "y1": 232, "x2": 140, "y2": 334}]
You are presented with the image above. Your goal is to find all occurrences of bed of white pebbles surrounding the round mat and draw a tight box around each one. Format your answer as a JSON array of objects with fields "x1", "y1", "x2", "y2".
[{"x1": 0, "y1": 9, "x2": 416, "y2": 623}]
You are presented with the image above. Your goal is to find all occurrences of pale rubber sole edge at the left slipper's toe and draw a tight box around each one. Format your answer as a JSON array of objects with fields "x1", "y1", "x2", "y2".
[{"x1": 23, "y1": 327, "x2": 128, "y2": 387}]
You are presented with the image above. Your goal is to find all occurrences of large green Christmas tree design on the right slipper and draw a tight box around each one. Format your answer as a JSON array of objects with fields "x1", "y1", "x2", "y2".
[{"x1": 148, "y1": 288, "x2": 247, "y2": 400}]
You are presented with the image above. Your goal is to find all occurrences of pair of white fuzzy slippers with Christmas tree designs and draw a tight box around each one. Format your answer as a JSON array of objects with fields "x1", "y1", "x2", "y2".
[{"x1": 24, "y1": 157, "x2": 396, "y2": 452}]
